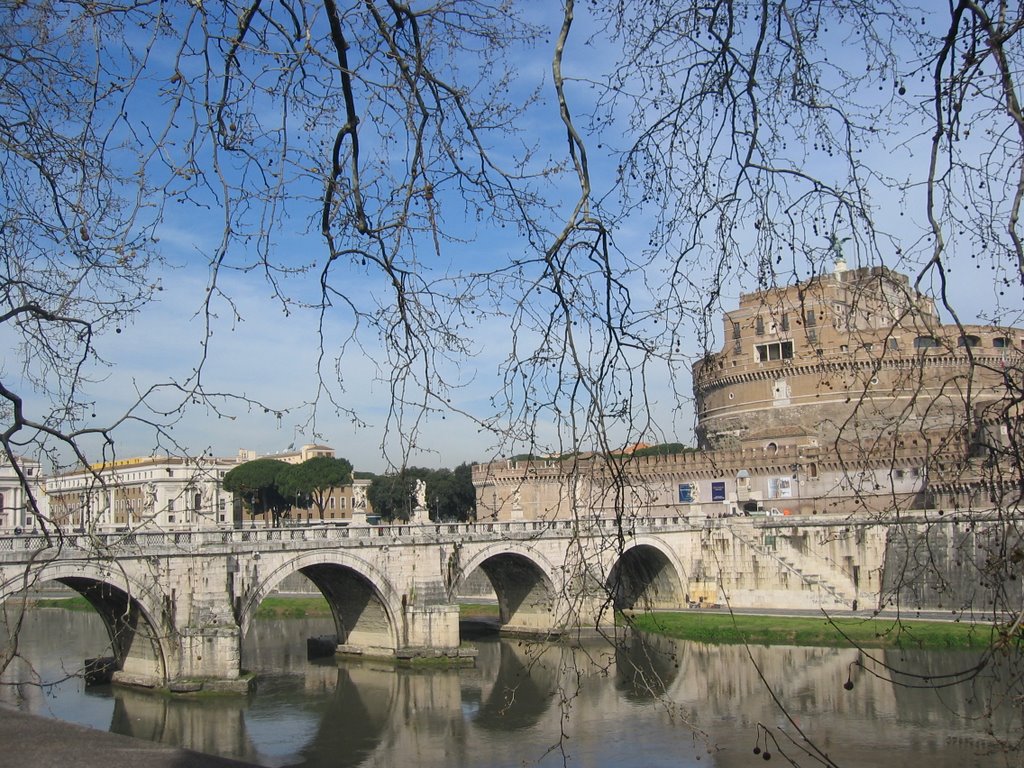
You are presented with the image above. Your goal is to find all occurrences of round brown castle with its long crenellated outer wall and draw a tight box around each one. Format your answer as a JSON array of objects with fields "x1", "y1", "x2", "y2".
[{"x1": 474, "y1": 259, "x2": 1024, "y2": 519}]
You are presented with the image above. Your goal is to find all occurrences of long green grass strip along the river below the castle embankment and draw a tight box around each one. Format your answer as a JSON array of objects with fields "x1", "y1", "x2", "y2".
[{"x1": 623, "y1": 610, "x2": 991, "y2": 650}]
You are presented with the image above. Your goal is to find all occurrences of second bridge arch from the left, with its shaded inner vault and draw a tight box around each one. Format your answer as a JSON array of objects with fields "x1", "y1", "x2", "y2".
[{"x1": 239, "y1": 550, "x2": 406, "y2": 655}]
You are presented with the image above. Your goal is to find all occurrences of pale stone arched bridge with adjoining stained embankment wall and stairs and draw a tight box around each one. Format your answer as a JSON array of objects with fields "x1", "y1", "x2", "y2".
[{"x1": 0, "y1": 517, "x2": 897, "y2": 690}]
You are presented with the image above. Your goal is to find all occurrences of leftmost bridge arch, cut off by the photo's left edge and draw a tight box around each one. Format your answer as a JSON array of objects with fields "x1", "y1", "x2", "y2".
[{"x1": 0, "y1": 560, "x2": 167, "y2": 686}]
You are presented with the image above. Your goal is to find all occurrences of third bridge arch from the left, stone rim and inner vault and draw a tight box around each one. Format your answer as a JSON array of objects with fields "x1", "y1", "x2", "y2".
[{"x1": 449, "y1": 541, "x2": 560, "y2": 634}]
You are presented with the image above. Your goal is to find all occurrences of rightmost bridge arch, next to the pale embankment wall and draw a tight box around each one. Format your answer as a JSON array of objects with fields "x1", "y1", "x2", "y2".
[{"x1": 606, "y1": 537, "x2": 688, "y2": 610}]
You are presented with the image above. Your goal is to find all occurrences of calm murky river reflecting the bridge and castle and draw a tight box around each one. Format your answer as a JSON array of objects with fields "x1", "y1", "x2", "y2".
[{"x1": 0, "y1": 608, "x2": 1024, "y2": 768}]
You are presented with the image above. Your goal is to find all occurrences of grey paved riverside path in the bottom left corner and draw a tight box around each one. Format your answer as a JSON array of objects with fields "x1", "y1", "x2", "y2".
[{"x1": 0, "y1": 707, "x2": 260, "y2": 768}]
